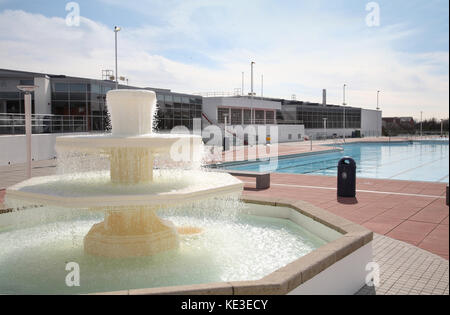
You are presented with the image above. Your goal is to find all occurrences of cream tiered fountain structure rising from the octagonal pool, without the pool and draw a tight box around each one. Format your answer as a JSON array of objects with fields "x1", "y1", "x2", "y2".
[{"x1": 7, "y1": 90, "x2": 243, "y2": 257}]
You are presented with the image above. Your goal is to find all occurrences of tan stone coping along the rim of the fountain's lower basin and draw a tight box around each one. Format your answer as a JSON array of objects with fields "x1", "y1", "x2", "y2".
[{"x1": 90, "y1": 196, "x2": 373, "y2": 295}]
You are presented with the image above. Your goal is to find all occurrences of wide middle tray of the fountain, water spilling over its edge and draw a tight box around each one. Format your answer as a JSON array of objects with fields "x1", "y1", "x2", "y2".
[{"x1": 6, "y1": 170, "x2": 244, "y2": 211}]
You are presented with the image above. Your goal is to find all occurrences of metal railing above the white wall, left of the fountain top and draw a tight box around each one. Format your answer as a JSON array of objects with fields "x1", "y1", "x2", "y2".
[{"x1": 0, "y1": 113, "x2": 107, "y2": 135}]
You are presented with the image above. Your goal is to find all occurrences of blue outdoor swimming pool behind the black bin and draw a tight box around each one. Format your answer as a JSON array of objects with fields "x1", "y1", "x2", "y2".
[{"x1": 224, "y1": 141, "x2": 449, "y2": 183}]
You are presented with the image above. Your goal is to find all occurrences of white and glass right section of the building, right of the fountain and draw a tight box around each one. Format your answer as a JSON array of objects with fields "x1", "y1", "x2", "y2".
[{"x1": 203, "y1": 96, "x2": 382, "y2": 140}]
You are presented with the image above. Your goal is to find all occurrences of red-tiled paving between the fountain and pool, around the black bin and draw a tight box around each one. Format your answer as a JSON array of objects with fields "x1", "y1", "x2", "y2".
[{"x1": 241, "y1": 173, "x2": 449, "y2": 260}]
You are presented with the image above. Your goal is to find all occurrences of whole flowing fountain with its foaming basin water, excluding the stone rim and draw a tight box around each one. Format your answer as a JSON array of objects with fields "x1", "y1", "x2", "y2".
[{"x1": 0, "y1": 90, "x2": 325, "y2": 293}]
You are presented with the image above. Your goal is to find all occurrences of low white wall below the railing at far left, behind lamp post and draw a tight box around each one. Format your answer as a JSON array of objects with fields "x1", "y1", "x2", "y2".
[{"x1": 0, "y1": 133, "x2": 87, "y2": 165}]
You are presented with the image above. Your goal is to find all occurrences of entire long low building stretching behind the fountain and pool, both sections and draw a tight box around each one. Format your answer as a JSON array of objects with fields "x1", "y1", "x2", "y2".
[{"x1": 0, "y1": 69, "x2": 382, "y2": 141}]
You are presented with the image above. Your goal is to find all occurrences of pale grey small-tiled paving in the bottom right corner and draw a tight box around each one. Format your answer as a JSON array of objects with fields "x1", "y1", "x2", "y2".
[{"x1": 357, "y1": 234, "x2": 449, "y2": 295}]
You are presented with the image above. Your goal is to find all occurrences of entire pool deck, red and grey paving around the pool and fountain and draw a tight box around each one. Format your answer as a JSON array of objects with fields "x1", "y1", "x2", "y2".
[{"x1": 0, "y1": 138, "x2": 449, "y2": 295}]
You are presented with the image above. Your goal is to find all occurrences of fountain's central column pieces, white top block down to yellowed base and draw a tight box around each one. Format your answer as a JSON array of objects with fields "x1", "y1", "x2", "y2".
[{"x1": 84, "y1": 90, "x2": 179, "y2": 257}]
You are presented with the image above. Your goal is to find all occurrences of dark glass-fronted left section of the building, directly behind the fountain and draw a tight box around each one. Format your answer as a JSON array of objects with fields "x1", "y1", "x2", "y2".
[{"x1": 0, "y1": 69, "x2": 202, "y2": 134}]
